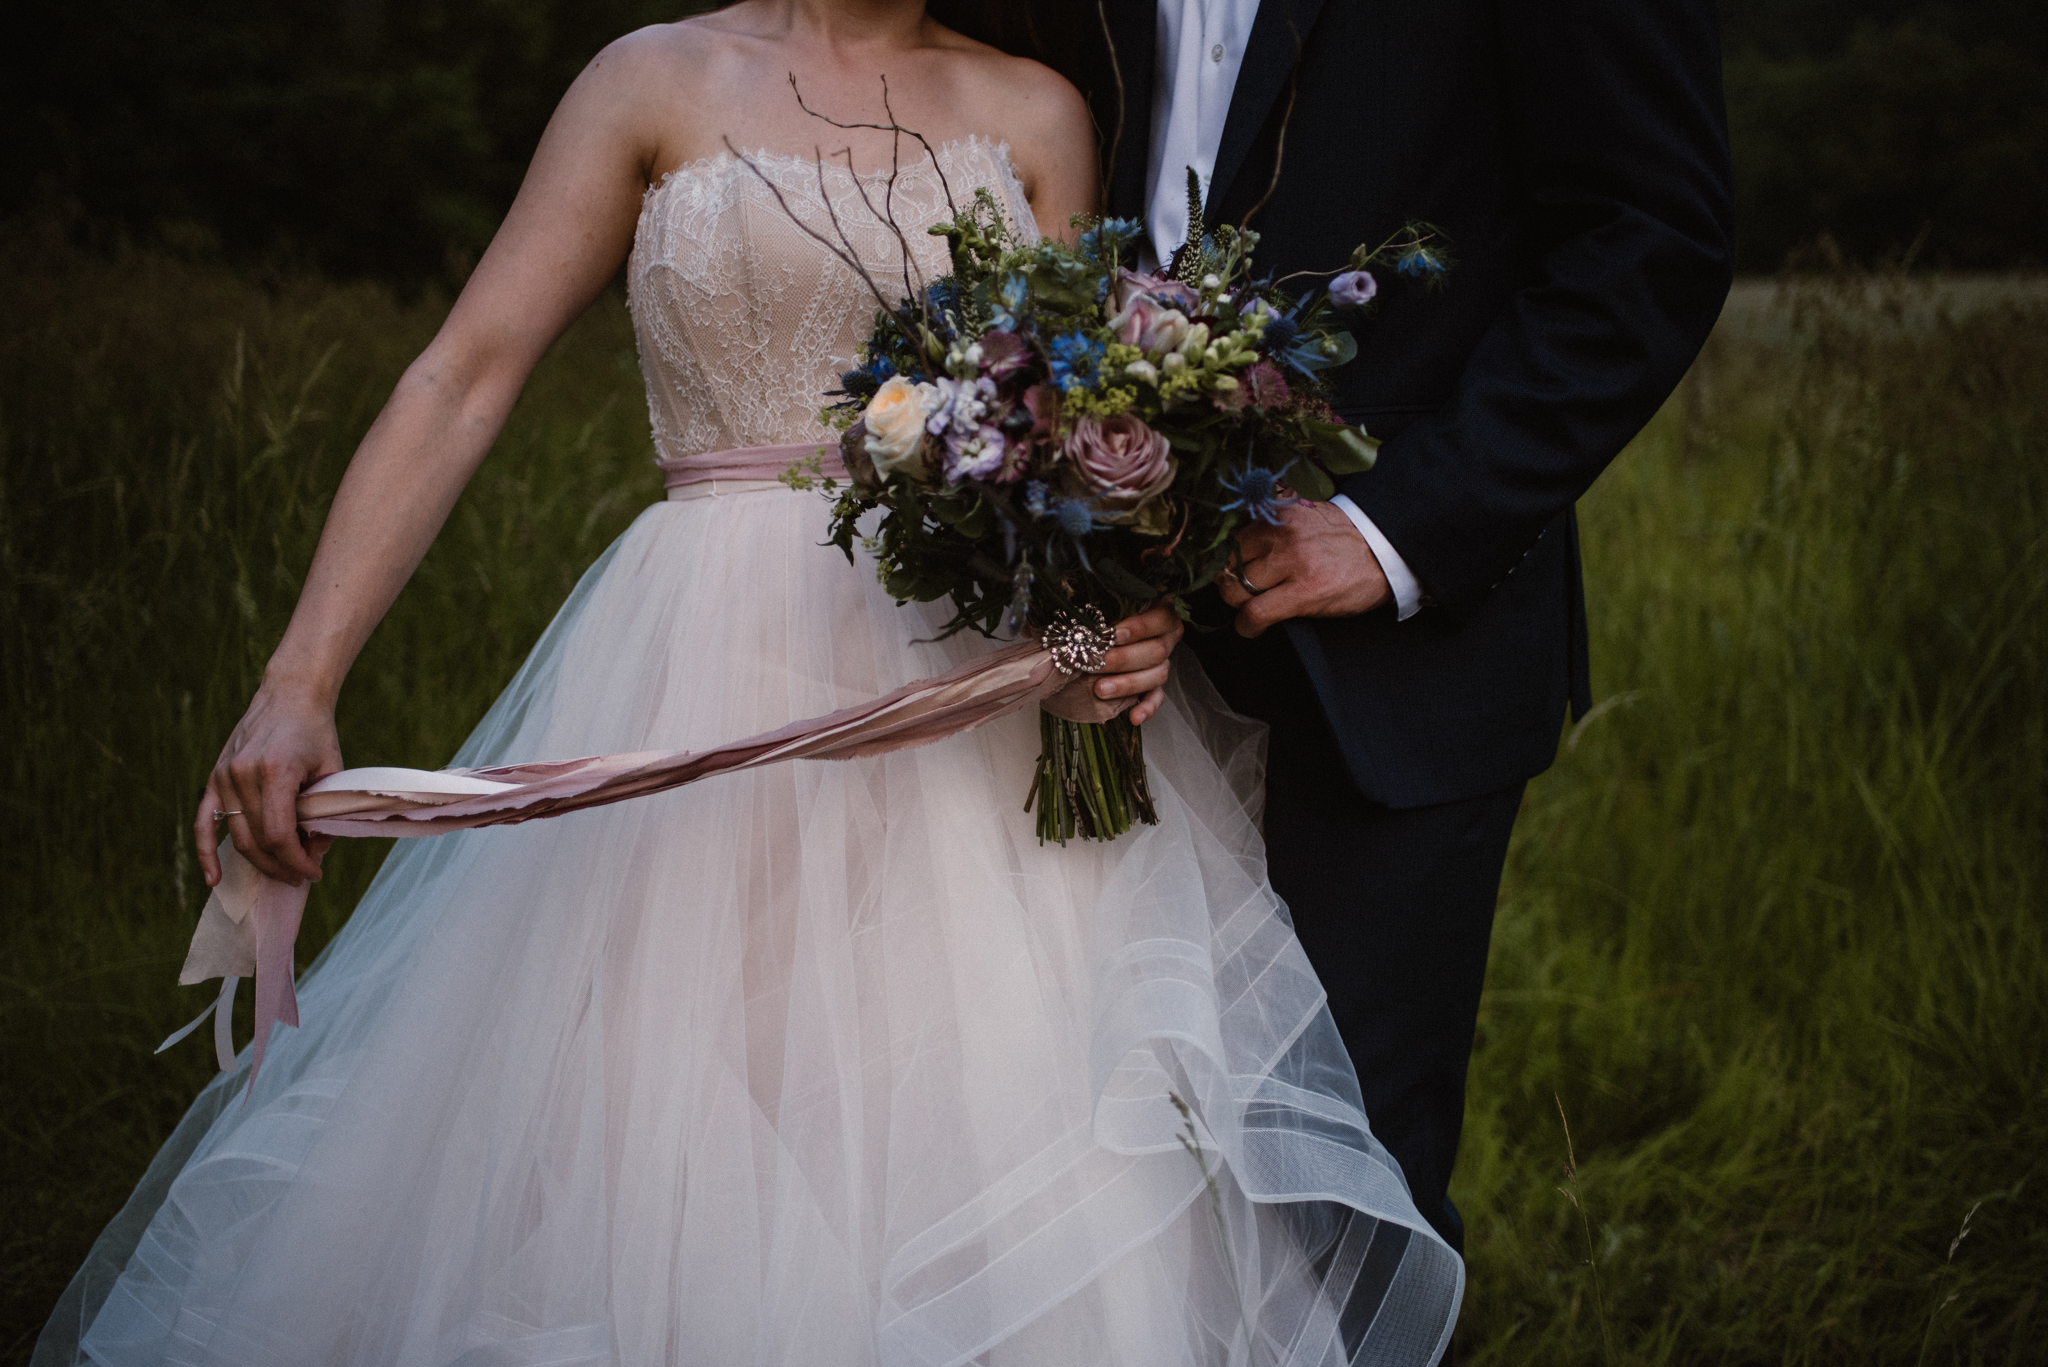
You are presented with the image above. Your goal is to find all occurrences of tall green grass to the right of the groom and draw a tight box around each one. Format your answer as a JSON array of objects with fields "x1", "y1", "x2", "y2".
[{"x1": 1454, "y1": 279, "x2": 2048, "y2": 1365}]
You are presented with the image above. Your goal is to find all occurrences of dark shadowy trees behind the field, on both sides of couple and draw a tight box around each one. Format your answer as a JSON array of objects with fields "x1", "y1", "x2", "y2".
[{"x1": 0, "y1": 0, "x2": 2048, "y2": 283}]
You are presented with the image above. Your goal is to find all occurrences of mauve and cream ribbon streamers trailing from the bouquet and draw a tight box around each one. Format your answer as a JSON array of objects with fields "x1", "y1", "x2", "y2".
[{"x1": 180, "y1": 641, "x2": 1135, "y2": 1103}]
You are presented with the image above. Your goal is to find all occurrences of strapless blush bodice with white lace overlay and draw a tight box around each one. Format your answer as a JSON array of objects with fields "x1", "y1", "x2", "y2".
[{"x1": 627, "y1": 137, "x2": 1038, "y2": 457}]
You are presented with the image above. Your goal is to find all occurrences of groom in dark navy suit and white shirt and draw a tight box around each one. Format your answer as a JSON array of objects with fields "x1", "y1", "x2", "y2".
[{"x1": 1083, "y1": 0, "x2": 1731, "y2": 1252}]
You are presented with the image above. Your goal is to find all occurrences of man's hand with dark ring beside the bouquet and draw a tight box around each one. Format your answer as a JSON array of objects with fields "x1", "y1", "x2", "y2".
[{"x1": 1217, "y1": 502, "x2": 1393, "y2": 635}]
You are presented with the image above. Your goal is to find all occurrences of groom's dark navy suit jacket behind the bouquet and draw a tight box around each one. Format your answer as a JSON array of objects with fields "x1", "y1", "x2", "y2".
[{"x1": 1083, "y1": 0, "x2": 1733, "y2": 807}]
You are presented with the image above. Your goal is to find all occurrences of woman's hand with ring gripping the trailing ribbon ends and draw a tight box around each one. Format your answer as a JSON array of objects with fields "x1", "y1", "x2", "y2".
[{"x1": 193, "y1": 685, "x2": 342, "y2": 887}]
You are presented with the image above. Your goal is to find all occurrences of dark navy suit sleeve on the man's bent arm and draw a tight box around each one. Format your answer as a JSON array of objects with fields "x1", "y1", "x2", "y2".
[{"x1": 1343, "y1": 0, "x2": 1733, "y2": 611}]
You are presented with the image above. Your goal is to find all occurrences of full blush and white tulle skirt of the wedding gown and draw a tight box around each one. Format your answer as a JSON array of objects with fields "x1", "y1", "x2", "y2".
[{"x1": 37, "y1": 490, "x2": 1464, "y2": 1367}]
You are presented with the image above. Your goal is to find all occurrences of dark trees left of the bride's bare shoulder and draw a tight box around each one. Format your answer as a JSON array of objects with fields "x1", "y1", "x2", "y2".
[{"x1": 0, "y1": 0, "x2": 709, "y2": 283}]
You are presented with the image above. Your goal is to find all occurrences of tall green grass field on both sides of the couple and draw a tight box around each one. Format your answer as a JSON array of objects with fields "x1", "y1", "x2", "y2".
[{"x1": 0, "y1": 230, "x2": 2048, "y2": 1363}]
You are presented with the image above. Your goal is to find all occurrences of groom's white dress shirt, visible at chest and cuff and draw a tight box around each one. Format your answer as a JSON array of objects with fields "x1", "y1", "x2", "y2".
[{"x1": 1145, "y1": 0, "x2": 1421, "y2": 621}]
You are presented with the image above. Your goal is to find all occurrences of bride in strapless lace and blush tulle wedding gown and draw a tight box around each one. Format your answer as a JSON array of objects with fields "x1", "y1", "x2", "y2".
[{"x1": 35, "y1": 0, "x2": 1462, "y2": 1367}]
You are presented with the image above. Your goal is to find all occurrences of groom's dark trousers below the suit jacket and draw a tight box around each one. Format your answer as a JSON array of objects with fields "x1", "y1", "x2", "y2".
[{"x1": 1190, "y1": 614, "x2": 1524, "y2": 1252}]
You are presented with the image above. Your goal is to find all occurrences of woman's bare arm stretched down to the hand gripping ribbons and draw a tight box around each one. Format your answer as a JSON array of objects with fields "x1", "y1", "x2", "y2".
[{"x1": 193, "y1": 39, "x2": 655, "y2": 885}]
